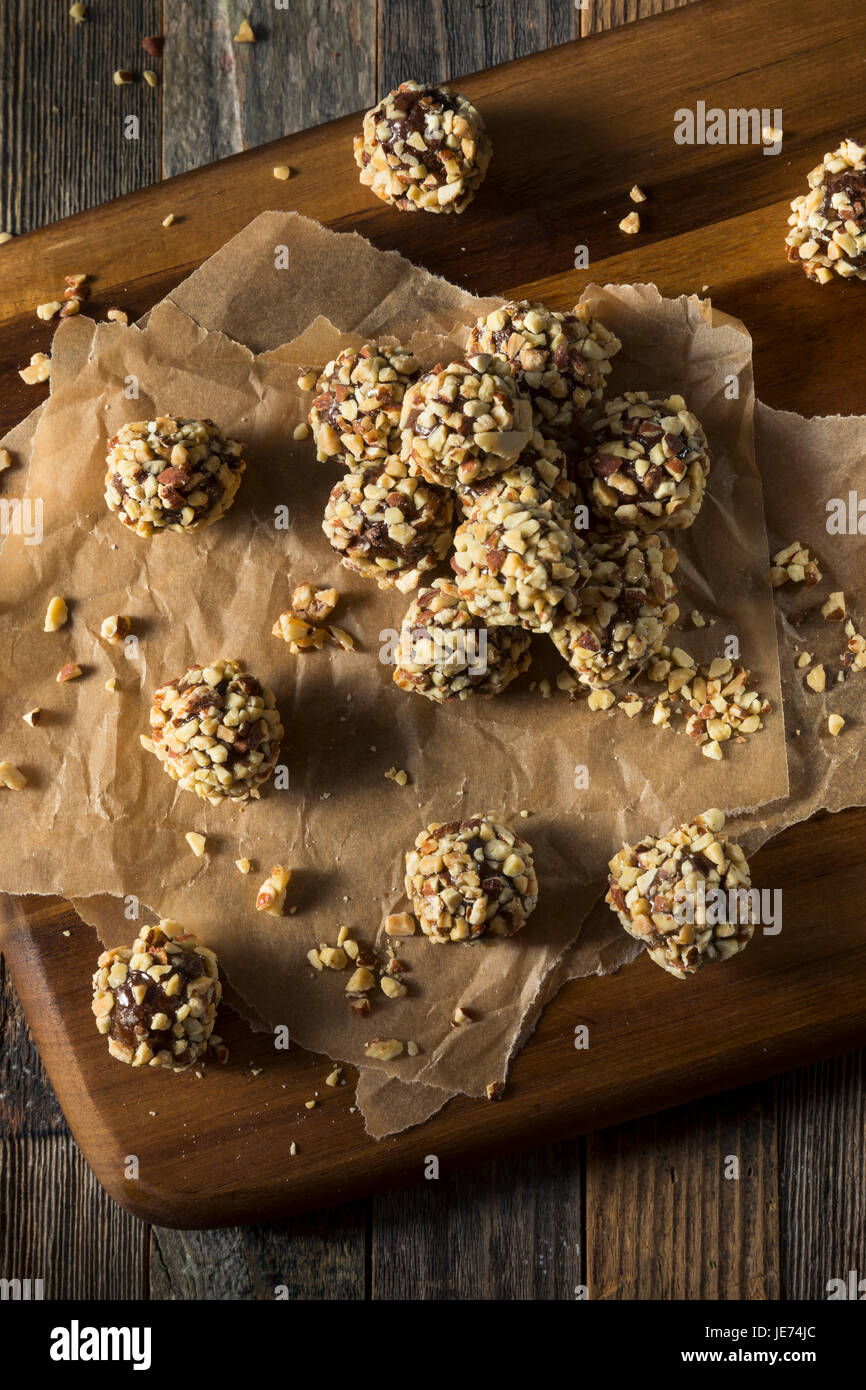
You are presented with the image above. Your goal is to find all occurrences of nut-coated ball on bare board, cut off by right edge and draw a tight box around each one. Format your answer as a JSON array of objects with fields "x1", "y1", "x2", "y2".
[{"x1": 785, "y1": 139, "x2": 866, "y2": 285}]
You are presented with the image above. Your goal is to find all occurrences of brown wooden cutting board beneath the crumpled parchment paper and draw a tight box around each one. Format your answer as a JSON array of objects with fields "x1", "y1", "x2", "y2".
[{"x1": 0, "y1": 0, "x2": 866, "y2": 1227}]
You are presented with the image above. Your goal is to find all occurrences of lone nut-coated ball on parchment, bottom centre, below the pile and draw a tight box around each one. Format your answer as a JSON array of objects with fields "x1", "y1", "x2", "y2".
[{"x1": 406, "y1": 815, "x2": 538, "y2": 941}]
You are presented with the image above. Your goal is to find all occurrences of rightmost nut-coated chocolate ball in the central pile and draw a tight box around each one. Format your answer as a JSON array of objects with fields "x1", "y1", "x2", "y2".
[{"x1": 582, "y1": 391, "x2": 710, "y2": 531}]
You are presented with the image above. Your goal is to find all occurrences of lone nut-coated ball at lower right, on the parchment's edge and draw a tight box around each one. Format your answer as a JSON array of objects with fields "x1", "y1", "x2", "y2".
[{"x1": 605, "y1": 809, "x2": 755, "y2": 980}]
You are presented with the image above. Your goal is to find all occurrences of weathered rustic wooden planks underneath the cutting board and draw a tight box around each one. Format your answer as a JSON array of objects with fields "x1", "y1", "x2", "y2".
[{"x1": 0, "y1": 0, "x2": 866, "y2": 1300}]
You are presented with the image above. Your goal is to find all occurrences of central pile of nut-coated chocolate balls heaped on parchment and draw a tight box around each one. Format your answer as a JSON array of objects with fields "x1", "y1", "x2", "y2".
[{"x1": 309, "y1": 302, "x2": 710, "y2": 701}]
